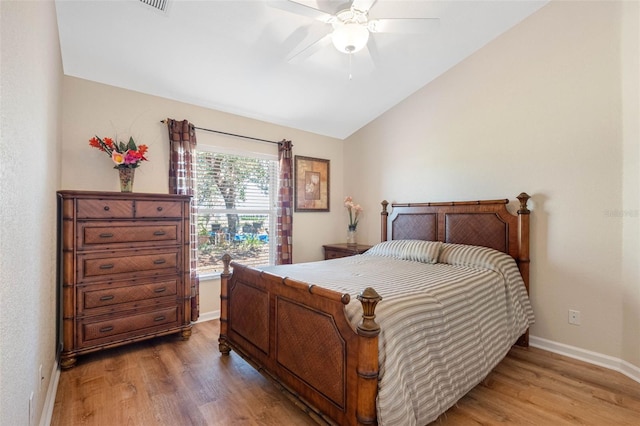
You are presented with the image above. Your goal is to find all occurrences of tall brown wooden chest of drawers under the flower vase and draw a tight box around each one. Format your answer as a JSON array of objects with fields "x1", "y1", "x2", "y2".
[{"x1": 58, "y1": 191, "x2": 191, "y2": 368}]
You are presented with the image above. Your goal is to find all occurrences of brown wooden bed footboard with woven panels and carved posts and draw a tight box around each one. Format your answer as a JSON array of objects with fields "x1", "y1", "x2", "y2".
[{"x1": 218, "y1": 255, "x2": 381, "y2": 425}]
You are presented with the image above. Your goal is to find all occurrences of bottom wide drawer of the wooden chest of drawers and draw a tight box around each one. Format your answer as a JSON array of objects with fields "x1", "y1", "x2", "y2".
[{"x1": 77, "y1": 306, "x2": 179, "y2": 347}]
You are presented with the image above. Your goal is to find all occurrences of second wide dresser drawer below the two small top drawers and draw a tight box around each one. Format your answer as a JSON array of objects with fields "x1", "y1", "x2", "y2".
[{"x1": 77, "y1": 247, "x2": 180, "y2": 281}]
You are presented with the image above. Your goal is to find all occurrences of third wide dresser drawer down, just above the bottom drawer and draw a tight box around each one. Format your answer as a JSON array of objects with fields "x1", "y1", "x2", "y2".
[{"x1": 76, "y1": 277, "x2": 179, "y2": 315}]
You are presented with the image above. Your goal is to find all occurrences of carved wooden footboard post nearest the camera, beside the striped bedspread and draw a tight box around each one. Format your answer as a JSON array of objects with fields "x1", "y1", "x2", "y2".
[{"x1": 356, "y1": 287, "x2": 382, "y2": 425}]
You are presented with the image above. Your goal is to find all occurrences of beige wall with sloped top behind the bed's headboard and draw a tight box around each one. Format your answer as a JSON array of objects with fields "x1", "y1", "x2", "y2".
[{"x1": 345, "y1": 1, "x2": 640, "y2": 370}]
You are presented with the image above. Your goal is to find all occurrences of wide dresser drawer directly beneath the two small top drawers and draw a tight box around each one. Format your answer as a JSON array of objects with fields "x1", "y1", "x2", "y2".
[{"x1": 77, "y1": 221, "x2": 182, "y2": 250}]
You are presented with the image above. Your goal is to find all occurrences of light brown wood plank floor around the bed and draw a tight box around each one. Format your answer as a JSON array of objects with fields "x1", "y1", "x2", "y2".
[{"x1": 51, "y1": 321, "x2": 640, "y2": 426}]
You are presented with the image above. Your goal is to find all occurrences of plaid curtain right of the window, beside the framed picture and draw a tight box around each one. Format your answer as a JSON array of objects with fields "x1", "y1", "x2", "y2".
[{"x1": 276, "y1": 140, "x2": 293, "y2": 265}]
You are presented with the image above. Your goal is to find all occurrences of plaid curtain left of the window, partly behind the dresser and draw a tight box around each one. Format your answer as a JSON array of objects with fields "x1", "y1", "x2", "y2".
[{"x1": 167, "y1": 118, "x2": 200, "y2": 321}]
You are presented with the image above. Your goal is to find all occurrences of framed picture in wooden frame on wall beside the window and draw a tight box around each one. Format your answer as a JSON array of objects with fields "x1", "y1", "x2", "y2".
[{"x1": 295, "y1": 155, "x2": 329, "y2": 212}]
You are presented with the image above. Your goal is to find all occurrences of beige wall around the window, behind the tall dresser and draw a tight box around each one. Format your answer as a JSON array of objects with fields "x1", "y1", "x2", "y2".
[{"x1": 62, "y1": 77, "x2": 346, "y2": 313}]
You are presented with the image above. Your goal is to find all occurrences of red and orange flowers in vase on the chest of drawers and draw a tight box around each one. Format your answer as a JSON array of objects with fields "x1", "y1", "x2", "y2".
[{"x1": 89, "y1": 136, "x2": 148, "y2": 192}]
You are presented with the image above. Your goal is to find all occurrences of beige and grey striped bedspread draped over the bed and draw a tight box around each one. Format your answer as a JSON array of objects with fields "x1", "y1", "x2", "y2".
[{"x1": 260, "y1": 243, "x2": 534, "y2": 426}]
